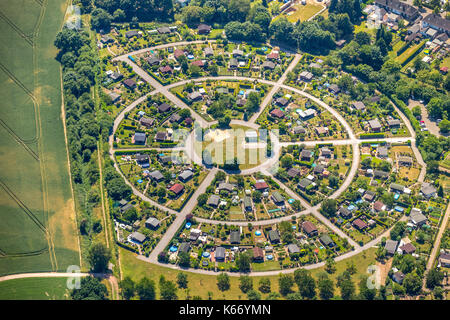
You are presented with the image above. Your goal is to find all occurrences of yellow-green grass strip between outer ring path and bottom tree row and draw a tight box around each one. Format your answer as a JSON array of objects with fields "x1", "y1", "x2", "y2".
[{"x1": 119, "y1": 248, "x2": 376, "y2": 300}]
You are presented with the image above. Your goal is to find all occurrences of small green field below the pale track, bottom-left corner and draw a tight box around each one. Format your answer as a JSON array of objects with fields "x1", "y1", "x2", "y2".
[{"x1": 0, "y1": 278, "x2": 69, "y2": 300}]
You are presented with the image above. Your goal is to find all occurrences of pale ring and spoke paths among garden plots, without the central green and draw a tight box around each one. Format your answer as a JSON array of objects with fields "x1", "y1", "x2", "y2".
[{"x1": 106, "y1": 41, "x2": 426, "y2": 276}]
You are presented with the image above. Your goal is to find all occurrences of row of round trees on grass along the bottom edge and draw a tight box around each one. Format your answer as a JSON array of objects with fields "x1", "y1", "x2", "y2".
[{"x1": 120, "y1": 266, "x2": 386, "y2": 300}]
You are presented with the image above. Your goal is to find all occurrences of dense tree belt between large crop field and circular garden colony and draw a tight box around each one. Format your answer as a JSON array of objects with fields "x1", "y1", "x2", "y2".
[{"x1": 54, "y1": 27, "x2": 118, "y2": 237}]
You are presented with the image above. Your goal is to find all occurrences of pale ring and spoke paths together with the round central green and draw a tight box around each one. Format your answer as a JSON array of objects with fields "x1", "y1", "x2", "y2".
[{"x1": 109, "y1": 43, "x2": 424, "y2": 276}]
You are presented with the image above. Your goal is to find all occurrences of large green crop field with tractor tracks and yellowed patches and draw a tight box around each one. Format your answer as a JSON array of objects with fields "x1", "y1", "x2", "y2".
[{"x1": 0, "y1": 0, "x2": 80, "y2": 276}]
